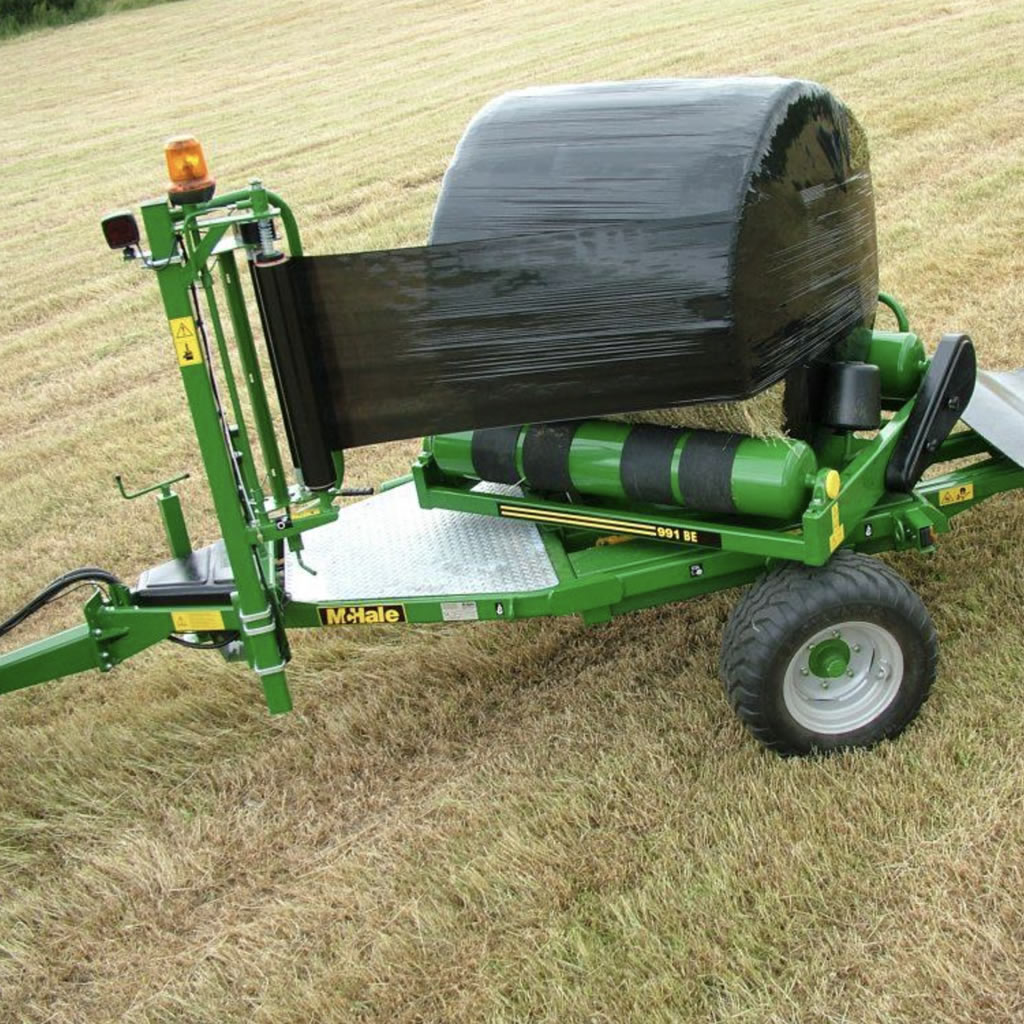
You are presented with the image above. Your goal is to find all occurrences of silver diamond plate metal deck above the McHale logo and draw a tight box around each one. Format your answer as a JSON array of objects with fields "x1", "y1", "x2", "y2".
[{"x1": 285, "y1": 483, "x2": 558, "y2": 604}]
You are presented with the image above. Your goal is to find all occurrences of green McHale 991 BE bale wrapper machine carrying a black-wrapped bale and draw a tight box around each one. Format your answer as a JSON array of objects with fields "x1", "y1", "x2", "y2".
[{"x1": 0, "y1": 80, "x2": 1024, "y2": 753}]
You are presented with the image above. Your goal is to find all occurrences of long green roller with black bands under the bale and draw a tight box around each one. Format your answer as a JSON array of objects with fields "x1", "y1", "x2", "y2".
[{"x1": 427, "y1": 420, "x2": 818, "y2": 519}]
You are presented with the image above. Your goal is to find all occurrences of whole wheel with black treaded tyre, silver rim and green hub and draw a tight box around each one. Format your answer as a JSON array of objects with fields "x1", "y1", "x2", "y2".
[{"x1": 720, "y1": 551, "x2": 938, "y2": 754}]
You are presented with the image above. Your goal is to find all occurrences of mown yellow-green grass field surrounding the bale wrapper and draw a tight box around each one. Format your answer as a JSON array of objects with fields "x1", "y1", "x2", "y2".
[{"x1": 0, "y1": 0, "x2": 1024, "y2": 1024}]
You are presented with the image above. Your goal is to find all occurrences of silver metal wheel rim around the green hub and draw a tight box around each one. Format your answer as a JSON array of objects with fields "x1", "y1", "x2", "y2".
[{"x1": 782, "y1": 622, "x2": 903, "y2": 736}]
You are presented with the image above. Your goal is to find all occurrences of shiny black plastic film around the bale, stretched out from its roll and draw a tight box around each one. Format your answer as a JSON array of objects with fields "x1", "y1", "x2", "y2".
[{"x1": 256, "y1": 78, "x2": 878, "y2": 447}]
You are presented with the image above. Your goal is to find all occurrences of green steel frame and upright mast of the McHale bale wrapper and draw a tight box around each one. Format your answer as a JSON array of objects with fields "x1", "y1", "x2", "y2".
[{"x1": 0, "y1": 174, "x2": 1024, "y2": 713}]
